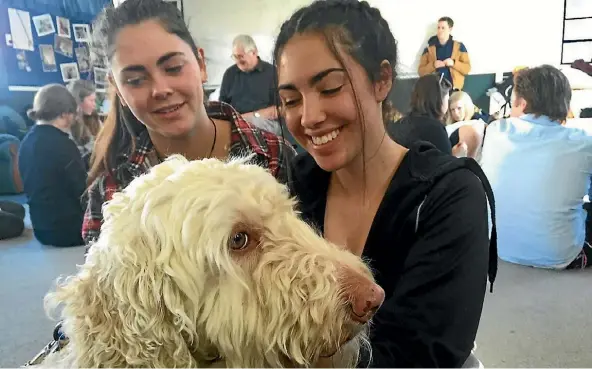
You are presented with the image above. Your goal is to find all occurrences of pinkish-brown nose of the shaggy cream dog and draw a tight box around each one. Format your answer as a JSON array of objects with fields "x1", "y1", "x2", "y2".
[{"x1": 344, "y1": 270, "x2": 384, "y2": 323}]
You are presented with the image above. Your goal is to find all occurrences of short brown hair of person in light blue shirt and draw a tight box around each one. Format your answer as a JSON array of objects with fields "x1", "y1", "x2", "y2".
[{"x1": 513, "y1": 65, "x2": 571, "y2": 122}]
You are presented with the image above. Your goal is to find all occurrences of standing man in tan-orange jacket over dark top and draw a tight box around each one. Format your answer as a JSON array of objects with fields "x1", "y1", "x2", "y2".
[{"x1": 418, "y1": 17, "x2": 471, "y2": 90}]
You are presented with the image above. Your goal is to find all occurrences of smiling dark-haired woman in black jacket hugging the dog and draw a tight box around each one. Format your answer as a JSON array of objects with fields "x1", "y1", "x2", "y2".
[{"x1": 274, "y1": 0, "x2": 497, "y2": 368}]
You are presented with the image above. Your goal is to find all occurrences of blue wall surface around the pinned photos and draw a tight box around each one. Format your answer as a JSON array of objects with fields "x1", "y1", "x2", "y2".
[{"x1": 0, "y1": 0, "x2": 111, "y2": 105}]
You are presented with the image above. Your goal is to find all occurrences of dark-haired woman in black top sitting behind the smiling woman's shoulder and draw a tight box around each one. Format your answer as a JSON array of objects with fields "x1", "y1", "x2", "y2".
[{"x1": 387, "y1": 74, "x2": 452, "y2": 154}]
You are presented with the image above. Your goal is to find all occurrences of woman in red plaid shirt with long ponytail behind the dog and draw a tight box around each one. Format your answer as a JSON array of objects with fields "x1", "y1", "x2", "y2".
[{"x1": 83, "y1": 0, "x2": 294, "y2": 247}]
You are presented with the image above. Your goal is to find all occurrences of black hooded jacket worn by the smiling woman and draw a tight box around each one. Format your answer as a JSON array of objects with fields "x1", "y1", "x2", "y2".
[{"x1": 290, "y1": 143, "x2": 497, "y2": 368}]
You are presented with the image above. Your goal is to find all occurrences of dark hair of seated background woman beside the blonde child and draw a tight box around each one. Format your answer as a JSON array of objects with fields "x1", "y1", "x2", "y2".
[{"x1": 409, "y1": 74, "x2": 450, "y2": 120}]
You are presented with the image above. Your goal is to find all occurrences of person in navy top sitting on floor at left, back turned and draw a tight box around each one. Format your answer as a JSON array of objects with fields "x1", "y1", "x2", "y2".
[{"x1": 19, "y1": 84, "x2": 86, "y2": 246}]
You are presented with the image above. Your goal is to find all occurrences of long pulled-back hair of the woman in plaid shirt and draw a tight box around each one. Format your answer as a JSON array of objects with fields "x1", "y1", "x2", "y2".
[{"x1": 88, "y1": 0, "x2": 199, "y2": 185}]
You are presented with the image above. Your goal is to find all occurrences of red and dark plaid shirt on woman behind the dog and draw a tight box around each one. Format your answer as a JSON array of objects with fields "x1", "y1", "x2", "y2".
[{"x1": 82, "y1": 102, "x2": 295, "y2": 245}]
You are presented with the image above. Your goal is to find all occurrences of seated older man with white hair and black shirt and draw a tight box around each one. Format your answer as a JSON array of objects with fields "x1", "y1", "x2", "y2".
[{"x1": 220, "y1": 35, "x2": 281, "y2": 134}]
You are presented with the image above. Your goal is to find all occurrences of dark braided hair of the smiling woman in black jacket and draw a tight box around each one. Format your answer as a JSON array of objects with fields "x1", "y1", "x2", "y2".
[{"x1": 273, "y1": 0, "x2": 397, "y2": 126}]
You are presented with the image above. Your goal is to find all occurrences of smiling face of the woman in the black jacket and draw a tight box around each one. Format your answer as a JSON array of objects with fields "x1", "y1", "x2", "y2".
[{"x1": 278, "y1": 34, "x2": 391, "y2": 171}]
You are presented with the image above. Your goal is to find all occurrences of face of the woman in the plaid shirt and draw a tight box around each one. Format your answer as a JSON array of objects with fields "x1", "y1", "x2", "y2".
[{"x1": 112, "y1": 21, "x2": 205, "y2": 138}]
